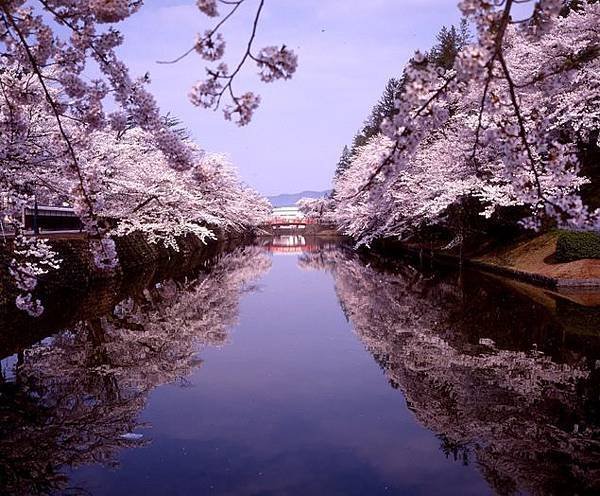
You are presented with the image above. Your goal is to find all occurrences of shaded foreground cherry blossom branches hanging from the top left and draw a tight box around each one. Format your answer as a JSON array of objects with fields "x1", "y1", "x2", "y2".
[{"x1": 0, "y1": 0, "x2": 297, "y2": 165}]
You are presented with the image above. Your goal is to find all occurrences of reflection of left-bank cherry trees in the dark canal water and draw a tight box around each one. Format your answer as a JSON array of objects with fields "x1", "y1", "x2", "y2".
[{"x1": 0, "y1": 247, "x2": 270, "y2": 494}]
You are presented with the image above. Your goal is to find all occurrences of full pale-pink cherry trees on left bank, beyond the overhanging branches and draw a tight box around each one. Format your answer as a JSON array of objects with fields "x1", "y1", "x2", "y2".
[{"x1": 78, "y1": 128, "x2": 270, "y2": 250}]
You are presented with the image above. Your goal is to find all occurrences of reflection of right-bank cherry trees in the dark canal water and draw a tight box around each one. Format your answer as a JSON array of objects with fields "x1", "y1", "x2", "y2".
[{"x1": 300, "y1": 250, "x2": 600, "y2": 494}]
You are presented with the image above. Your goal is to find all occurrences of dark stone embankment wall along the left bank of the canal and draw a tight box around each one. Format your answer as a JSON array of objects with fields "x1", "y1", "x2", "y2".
[{"x1": 0, "y1": 229, "x2": 253, "y2": 359}]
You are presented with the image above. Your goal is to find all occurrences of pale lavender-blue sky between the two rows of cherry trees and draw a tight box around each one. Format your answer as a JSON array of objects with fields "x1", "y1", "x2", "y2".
[{"x1": 119, "y1": 0, "x2": 460, "y2": 195}]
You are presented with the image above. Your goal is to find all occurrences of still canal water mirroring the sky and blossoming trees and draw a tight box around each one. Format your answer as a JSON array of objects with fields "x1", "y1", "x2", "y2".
[{"x1": 0, "y1": 238, "x2": 600, "y2": 496}]
